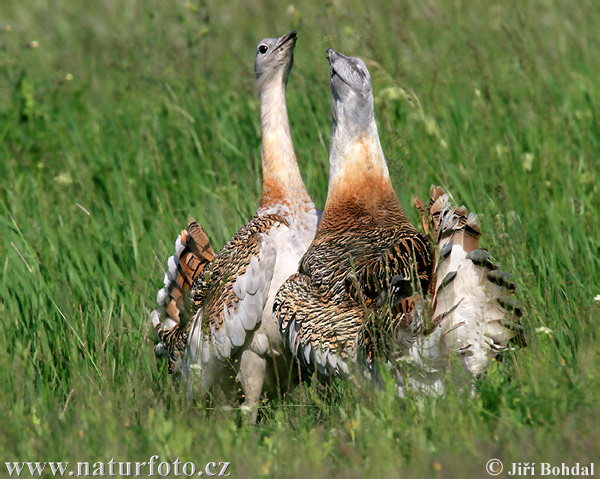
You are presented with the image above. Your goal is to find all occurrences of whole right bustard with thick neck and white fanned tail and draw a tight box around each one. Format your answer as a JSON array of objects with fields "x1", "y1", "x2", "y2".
[{"x1": 273, "y1": 49, "x2": 524, "y2": 394}]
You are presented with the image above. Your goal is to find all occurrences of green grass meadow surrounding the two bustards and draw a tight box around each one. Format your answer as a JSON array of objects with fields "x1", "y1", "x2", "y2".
[{"x1": 0, "y1": 0, "x2": 600, "y2": 478}]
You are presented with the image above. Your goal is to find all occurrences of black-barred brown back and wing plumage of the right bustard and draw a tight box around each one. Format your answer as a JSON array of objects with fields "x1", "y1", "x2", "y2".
[{"x1": 274, "y1": 225, "x2": 432, "y2": 374}]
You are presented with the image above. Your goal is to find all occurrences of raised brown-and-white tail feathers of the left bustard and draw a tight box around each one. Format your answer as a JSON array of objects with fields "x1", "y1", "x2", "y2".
[{"x1": 150, "y1": 217, "x2": 215, "y2": 373}]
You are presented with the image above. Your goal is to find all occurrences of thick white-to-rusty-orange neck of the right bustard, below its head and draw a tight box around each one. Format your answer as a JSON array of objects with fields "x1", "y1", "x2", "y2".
[{"x1": 319, "y1": 115, "x2": 406, "y2": 229}]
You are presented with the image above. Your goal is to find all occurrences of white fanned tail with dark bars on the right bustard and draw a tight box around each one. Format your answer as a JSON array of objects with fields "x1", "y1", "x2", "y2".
[{"x1": 415, "y1": 185, "x2": 526, "y2": 377}]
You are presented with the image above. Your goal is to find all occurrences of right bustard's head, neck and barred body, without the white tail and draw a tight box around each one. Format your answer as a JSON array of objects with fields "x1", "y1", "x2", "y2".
[{"x1": 273, "y1": 49, "x2": 433, "y2": 375}]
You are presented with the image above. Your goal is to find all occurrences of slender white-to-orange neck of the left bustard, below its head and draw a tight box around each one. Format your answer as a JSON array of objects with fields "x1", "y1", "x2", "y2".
[{"x1": 259, "y1": 73, "x2": 314, "y2": 211}]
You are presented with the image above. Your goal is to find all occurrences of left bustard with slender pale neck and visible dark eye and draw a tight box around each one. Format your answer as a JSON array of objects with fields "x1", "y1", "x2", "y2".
[{"x1": 152, "y1": 32, "x2": 318, "y2": 422}]
